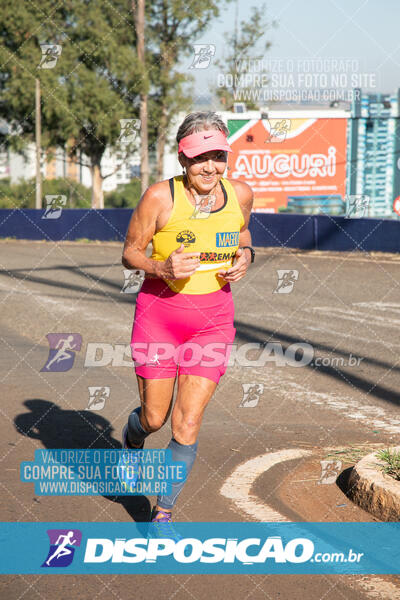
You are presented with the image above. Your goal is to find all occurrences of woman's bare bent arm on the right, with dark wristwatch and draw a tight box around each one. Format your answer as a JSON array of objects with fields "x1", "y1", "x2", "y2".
[{"x1": 218, "y1": 179, "x2": 254, "y2": 281}]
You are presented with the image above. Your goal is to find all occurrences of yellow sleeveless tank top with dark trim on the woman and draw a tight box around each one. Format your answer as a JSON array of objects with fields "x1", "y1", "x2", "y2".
[{"x1": 151, "y1": 176, "x2": 244, "y2": 294}]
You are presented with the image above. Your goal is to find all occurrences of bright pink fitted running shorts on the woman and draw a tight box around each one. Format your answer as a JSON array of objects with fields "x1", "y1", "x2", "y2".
[{"x1": 131, "y1": 279, "x2": 236, "y2": 383}]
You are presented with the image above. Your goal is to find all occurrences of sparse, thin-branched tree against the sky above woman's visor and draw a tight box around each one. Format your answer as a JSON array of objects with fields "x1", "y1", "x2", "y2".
[{"x1": 215, "y1": 4, "x2": 277, "y2": 110}]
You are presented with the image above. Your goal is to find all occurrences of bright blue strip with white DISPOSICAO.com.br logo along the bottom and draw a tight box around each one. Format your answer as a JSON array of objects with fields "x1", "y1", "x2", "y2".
[{"x1": 0, "y1": 522, "x2": 400, "y2": 574}]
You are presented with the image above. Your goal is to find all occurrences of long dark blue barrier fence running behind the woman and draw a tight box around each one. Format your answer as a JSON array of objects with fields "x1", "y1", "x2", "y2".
[{"x1": 0, "y1": 208, "x2": 400, "y2": 252}]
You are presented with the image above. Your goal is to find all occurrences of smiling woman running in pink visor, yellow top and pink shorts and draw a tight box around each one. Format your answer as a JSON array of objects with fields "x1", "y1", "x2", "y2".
[{"x1": 122, "y1": 112, "x2": 254, "y2": 523}]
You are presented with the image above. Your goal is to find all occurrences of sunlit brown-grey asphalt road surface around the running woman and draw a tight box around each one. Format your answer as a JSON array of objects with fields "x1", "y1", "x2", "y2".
[{"x1": 0, "y1": 241, "x2": 400, "y2": 600}]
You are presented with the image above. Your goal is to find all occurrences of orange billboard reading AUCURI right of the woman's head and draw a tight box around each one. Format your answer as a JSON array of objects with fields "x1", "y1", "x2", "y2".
[{"x1": 228, "y1": 118, "x2": 347, "y2": 212}]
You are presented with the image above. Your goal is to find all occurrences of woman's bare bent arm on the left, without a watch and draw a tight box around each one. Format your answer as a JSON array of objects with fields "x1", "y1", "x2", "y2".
[{"x1": 122, "y1": 183, "x2": 199, "y2": 279}]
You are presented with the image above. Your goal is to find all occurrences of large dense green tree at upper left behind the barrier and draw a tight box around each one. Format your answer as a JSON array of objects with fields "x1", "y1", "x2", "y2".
[{"x1": 0, "y1": 0, "x2": 143, "y2": 208}]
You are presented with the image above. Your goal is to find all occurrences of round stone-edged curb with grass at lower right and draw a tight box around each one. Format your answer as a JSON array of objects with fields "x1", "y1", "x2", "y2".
[{"x1": 347, "y1": 446, "x2": 400, "y2": 521}]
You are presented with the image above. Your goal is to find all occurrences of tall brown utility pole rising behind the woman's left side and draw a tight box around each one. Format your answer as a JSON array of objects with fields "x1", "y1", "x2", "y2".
[{"x1": 132, "y1": 0, "x2": 149, "y2": 194}]
